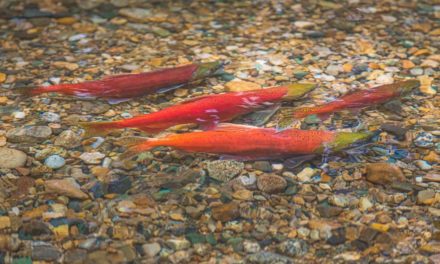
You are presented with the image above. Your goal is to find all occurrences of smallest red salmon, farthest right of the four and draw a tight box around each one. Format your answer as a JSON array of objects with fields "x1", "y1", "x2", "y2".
[{"x1": 280, "y1": 80, "x2": 420, "y2": 127}]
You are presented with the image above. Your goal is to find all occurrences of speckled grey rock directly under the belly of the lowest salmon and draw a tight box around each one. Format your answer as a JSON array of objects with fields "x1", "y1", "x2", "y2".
[{"x1": 206, "y1": 160, "x2": 244, "y2": 182}]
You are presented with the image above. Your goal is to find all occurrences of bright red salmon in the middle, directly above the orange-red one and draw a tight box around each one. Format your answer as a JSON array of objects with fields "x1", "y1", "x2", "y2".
[{"x1": 80, "y1": 83, "x2": 315, "y2": 136}]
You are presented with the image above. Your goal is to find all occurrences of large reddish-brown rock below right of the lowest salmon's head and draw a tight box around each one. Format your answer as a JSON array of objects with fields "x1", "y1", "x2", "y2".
[{"x1": 367, "y1": 162, "x2": 405, "y2": 185}]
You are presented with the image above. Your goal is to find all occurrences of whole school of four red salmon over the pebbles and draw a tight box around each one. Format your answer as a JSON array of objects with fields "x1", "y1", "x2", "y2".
[{"x1": 16, "y1": 62, "x2": 420, "y2": 160}]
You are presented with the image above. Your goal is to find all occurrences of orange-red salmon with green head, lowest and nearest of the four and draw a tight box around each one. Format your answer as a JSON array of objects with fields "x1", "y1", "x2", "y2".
[{"x1": 119, "y1": 124, "x2": 372, "y2": 160}]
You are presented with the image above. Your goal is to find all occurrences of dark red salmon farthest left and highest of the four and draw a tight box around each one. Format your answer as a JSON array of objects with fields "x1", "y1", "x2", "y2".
[{"x1": 17, "y1": 62, "x2": 223, "y2": 103}]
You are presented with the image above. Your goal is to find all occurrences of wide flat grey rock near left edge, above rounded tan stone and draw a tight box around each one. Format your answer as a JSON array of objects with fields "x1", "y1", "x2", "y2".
[{"x1": 6, "y1": 126, "x2": 52, "y2": 143}]
